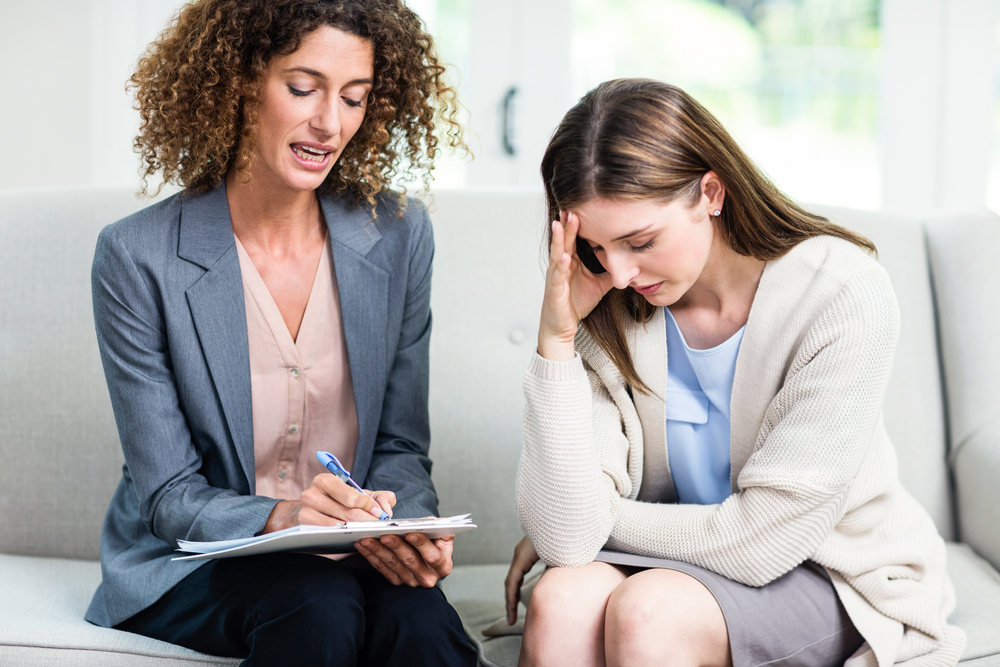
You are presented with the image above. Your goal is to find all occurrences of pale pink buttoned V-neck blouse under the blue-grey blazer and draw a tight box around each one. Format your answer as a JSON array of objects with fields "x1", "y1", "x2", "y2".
[{"x1": 236, "y1": 239, "x2": 358, "y2": 500}]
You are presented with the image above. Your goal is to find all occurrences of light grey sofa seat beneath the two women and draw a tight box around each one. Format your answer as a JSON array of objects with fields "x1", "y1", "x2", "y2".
[{"x1": 0, "y1": 543, "x2": 1000, "y2": 667}]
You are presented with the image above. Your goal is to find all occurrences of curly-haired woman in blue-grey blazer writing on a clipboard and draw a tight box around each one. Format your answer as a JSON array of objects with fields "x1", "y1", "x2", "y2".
[{"x1": 87, "y1": 0, "x2": 476, "y2": 665}]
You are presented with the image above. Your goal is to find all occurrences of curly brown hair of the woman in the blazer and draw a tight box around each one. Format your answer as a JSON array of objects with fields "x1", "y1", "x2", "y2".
[{"x1": 129, "y1": 0, "x2": 468, "y2": 207}]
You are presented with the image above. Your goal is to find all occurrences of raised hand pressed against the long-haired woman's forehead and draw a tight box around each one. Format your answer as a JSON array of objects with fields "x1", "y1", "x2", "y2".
[{"x1": 538, "y1": 211, "x2": 612, "y2": 361}]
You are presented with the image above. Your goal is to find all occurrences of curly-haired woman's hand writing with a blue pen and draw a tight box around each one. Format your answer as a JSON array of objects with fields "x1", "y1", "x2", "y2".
[{"x1": 261, "y1": 473, "x2": 396, "y2": 534}]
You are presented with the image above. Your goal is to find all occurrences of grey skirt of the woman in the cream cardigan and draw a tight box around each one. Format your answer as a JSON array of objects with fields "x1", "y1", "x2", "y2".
[{"x1": 595, "y1": 551, "x2": 864, "y2": 667}]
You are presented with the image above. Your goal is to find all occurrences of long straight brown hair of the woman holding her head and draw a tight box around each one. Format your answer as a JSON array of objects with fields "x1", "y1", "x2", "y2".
[{"x1": 541, "y1": 79, "x2": 875, "y2": 393}]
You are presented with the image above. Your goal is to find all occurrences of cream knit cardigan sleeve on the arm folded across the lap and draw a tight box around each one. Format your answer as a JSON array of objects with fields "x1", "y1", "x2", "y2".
[{"x1": 608, "y1": 264, "x2": 899, "y2": 586}]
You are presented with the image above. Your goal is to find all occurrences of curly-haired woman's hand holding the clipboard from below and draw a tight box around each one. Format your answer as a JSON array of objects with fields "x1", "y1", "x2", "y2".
[{"x1": 354, "y1": 533, "x2": 455, "y2": 588}]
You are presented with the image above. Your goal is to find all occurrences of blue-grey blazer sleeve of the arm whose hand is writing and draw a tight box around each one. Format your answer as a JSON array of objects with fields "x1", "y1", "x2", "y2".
[{"x1": 91, "y1": 226, "x2": 277, "y2": 545}]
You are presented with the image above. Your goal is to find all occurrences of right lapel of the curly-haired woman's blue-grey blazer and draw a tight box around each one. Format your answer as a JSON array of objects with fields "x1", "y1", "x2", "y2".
[{"x1": 320, "y1": 197, "x2": 389, "y2": 481}]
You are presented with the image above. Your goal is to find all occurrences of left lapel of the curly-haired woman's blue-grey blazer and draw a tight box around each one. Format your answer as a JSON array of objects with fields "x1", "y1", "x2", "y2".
[{"x1": 177, "y1": 183, "x2": 256, "y2": 494}]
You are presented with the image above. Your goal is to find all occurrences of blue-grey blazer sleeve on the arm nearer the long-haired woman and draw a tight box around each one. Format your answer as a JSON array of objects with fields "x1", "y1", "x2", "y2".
[{"x1": 365, "y1": 202, "x2": 438, "y2": 518}]
